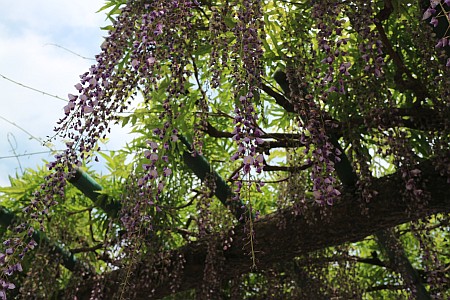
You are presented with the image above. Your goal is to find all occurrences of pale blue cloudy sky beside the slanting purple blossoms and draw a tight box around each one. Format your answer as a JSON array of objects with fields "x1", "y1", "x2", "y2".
[{"x1": 0, "y1": 0, "x2": 130, "y2": 186}]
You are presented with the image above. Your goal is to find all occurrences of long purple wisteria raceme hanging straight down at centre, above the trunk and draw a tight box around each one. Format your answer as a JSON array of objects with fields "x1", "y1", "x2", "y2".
[{"x1": 231, "y1": 0, "x2": 264, "y2": 198}]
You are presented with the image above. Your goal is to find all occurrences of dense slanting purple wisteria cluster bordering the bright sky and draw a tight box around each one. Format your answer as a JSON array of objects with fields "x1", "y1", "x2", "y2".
[{"x1": 55, "y1": 1, "x2": 194, "y2": 169}]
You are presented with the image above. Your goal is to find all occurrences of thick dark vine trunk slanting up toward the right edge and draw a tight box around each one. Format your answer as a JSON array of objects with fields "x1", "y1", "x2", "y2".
[{"x1": 75, "y1": 161, "x2": 450, "y2": 299}]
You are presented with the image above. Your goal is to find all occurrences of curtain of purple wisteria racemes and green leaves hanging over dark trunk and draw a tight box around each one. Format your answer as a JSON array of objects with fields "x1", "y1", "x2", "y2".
[{"x1": 0, "y1": 0, "x2": 450, "y2": 299}]
